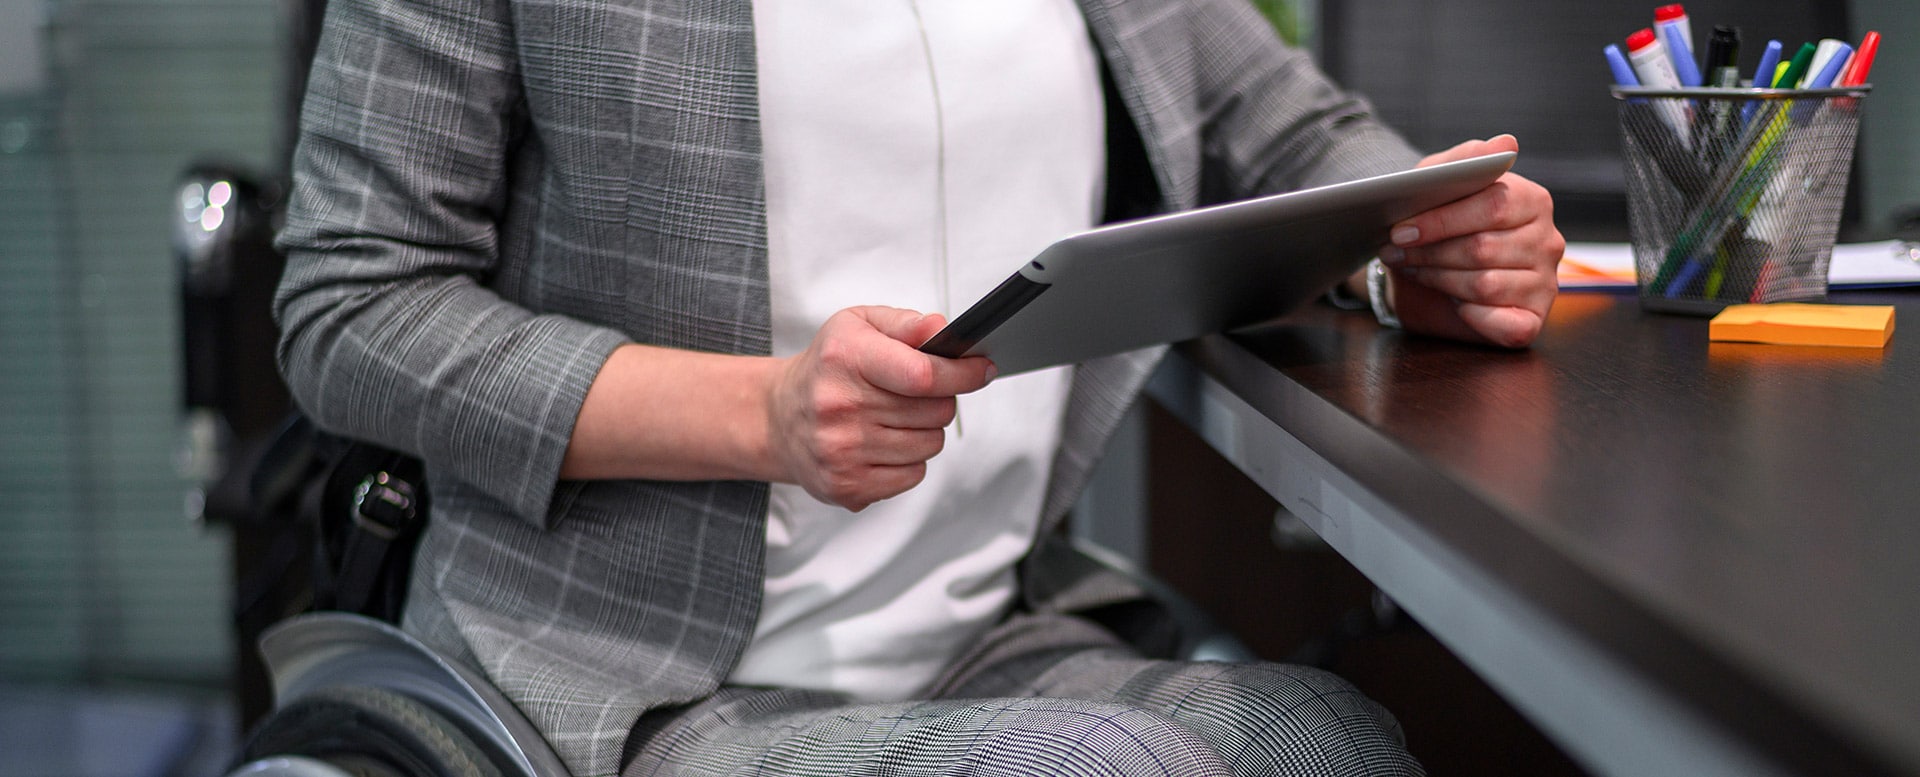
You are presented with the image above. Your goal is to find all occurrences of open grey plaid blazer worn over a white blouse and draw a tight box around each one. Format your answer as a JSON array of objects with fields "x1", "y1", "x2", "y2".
[{"x1": 275, "y1": 0, "x2": 1415, "y2": 775}]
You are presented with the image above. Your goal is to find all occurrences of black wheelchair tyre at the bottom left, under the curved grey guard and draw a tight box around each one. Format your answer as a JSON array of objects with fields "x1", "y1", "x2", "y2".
[{"x1": 240, "y1": 687, "x2": 501, "y2": 777}]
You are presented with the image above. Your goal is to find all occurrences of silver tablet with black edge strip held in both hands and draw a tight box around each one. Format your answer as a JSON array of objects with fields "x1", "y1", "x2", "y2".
[{"x1": 920, "y1": 152, "x2": 1515, "y2": 374}]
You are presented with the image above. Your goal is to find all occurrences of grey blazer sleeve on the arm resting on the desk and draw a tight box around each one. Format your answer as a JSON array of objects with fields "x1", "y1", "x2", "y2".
[{"x1": 1190, "y1": 0, "x2": 1421, "y2": 201}]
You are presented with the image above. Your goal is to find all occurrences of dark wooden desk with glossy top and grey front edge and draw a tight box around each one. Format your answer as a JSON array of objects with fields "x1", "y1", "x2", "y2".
[{"x1": 1152, "y1": 294, "x2": 1920, "y2": 775}]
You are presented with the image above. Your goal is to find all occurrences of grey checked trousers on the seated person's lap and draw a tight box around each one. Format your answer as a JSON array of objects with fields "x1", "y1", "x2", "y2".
[{"x1": 624, "y1": 616, "x2": 1425, "y2": 777}]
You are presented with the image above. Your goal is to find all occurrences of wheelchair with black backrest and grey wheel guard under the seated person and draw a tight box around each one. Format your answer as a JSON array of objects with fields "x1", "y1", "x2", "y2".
[{"x1": 175, "y1": 165, "x2": 1252, "y2": 777}]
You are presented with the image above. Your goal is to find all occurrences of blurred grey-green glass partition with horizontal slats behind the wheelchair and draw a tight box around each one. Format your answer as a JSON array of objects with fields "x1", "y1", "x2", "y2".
[{"x1": 0, "y1": 0, "x2": 284, "y2": 681}]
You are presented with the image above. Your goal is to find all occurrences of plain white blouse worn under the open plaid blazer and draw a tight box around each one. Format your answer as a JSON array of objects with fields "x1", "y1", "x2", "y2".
[{"x1": 730, "y1": 0, "x2": 1106, "y2": 700}]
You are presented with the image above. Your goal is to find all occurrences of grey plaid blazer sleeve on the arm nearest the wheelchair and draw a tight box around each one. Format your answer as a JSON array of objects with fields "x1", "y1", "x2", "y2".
[{"x1": 275, "y1": 0, "x2": 626, "y2": 526}]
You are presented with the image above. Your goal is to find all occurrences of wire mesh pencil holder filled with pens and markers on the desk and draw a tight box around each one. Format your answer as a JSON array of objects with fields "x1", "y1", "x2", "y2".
[{"x1": 1613, "y1": 86, "x2": 1868, "y2": 315}]
